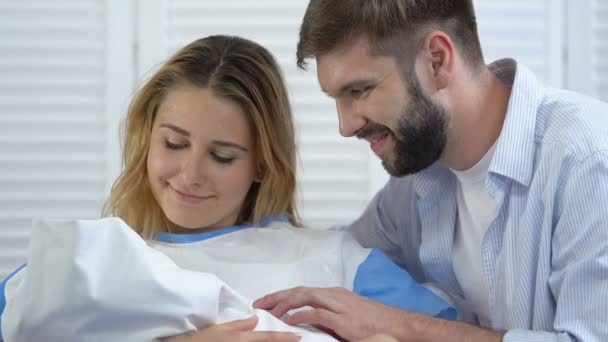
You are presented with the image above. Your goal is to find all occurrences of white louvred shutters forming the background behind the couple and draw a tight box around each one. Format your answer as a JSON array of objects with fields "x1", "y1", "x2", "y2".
[{"x1": 0, "y1": 0, "x2": 608, "y2": 278}]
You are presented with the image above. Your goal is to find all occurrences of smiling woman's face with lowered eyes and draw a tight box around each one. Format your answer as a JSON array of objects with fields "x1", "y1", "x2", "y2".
[{"x1": 147, "y1": 86, "x2": 256, "y2": 233}]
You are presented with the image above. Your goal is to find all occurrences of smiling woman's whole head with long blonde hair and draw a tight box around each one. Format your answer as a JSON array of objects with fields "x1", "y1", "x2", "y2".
[{"x1": 105, "y1": 36, "x2": 299, "y2": 238}]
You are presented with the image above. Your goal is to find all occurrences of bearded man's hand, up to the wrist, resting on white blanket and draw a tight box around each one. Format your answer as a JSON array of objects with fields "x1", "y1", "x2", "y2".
[{"x1": 253, "y1": 287, "x2": 405, "y2": 341}]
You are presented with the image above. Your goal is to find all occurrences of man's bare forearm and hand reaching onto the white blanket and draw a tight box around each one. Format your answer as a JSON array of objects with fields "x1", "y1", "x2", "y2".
[{"x1": 253, "y1": 287, "x2": 504, "y2": 342}]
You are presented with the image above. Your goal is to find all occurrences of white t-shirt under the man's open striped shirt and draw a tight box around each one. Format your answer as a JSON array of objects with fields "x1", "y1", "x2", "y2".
[{"x1": 452, "y1": 144, "x2": 496, "y2": 326}]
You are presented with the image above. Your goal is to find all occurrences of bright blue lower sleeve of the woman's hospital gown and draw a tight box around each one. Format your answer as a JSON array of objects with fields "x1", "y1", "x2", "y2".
[{"x1": 353, "y1": 249, "x2": 457, "y2": 319}]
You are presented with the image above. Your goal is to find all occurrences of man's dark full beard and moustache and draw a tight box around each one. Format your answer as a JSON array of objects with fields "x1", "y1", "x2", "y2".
[{"x1": 357, "y1": 77, "x2": 449, "y2": 177}]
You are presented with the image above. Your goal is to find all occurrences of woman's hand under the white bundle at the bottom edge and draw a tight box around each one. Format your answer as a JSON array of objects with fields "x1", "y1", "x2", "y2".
[{"x1": 161, "y1": 316, "x2": 300, "y2": 342}]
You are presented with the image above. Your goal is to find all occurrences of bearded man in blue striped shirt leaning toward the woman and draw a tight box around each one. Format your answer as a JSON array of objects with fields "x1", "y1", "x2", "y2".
[{"x1": 255, "y1": 0, "x2": 608, "y2": 342}]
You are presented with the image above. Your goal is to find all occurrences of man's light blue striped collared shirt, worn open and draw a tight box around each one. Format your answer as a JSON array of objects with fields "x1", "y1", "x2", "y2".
[{"x1": 350, "y1": 59, "x2": 608, "y2": 342}]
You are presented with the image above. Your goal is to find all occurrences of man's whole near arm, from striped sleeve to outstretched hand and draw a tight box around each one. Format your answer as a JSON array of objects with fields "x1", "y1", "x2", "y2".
[{"x1": 254, "y1": 151, "x2": 608, "y2": 342}]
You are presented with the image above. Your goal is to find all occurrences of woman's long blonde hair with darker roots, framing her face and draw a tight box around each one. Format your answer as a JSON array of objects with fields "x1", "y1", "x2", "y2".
[{"x1": 103, "y1": 36, "x2": 300, "y2": 238}]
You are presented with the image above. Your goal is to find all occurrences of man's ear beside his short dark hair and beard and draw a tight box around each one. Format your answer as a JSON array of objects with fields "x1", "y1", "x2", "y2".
[{"x1": 420, "y1": 31, "x2": 456, "y2": 90}]
